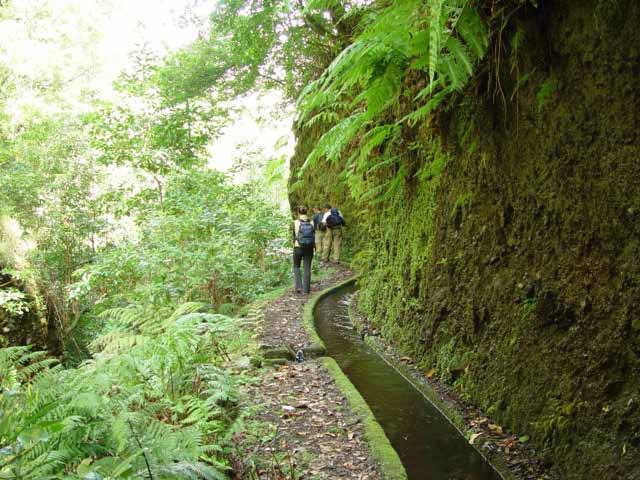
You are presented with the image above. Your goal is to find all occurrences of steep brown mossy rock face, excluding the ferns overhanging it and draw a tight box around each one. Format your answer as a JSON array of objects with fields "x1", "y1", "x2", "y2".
[{"x1": 291, "y1": 0, "x2": 640, "y2": 480}]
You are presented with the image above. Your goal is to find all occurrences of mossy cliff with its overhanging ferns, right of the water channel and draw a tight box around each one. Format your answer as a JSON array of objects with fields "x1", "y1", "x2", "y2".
[{"x1": 290, "y1": 0, "x2": 640, "y2": 480}]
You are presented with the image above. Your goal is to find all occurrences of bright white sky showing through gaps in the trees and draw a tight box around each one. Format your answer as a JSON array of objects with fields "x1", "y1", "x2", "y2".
[{"x1": 0, "y1": 0, "x2": 291, "y2": 169}]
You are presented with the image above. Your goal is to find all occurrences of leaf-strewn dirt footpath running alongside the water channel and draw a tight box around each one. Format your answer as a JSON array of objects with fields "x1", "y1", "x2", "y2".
[{"x1": 229, "y1": 267, "x2": 383, "y2": 480}]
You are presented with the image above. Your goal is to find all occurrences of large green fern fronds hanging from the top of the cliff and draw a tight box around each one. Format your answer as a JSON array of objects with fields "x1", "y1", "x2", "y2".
[{"x1": 298, "y1": 0, "x2": 488, "y2": 198}]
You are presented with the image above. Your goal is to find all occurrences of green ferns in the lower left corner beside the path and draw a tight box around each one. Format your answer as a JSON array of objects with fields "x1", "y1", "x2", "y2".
[{"x1": 0, "y1": 305, "x2": 238, "y2": 479}]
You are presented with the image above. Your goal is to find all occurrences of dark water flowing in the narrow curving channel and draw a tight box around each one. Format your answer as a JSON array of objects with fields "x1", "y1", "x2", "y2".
[{"x1": 315, "y1": 287, "x2": 501, "y2": 480}]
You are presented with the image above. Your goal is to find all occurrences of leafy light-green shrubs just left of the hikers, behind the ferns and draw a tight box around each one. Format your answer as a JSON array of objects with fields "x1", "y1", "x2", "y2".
[{"x1": 72, "y1": 171, "x2": 288, "y2": 322}]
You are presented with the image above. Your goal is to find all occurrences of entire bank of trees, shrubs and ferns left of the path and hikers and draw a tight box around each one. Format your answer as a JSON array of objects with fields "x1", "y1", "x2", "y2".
[{"x1": 0, "y1": 2, "x2": 290, "y2": 480}]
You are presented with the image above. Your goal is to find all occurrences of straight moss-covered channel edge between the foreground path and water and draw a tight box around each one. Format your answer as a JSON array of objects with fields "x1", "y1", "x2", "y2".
[{"x1": 320, "y1": 357, "x2": 407, "y2": 480}]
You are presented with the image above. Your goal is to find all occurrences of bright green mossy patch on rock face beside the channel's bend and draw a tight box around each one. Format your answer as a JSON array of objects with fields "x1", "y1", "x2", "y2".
[{"x1": 358, "y1": 141, "x2": 447, "y2": 353}]
